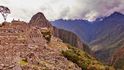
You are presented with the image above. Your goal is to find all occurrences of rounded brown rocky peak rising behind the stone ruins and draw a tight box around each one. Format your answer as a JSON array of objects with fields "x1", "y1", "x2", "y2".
[{"x1": 29, "y1": 12, "x2": 52, "y2": 27}]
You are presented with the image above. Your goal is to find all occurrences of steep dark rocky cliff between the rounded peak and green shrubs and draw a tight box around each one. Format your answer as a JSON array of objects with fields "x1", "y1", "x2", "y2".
[{"x1": 53, "y1": 27, "x2": 90, "y2": 53}]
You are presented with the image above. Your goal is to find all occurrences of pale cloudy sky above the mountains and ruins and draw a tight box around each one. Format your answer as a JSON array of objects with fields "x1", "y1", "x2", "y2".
[{"x1": 0, "y1": 0, "x2": 124, "y2": 22}]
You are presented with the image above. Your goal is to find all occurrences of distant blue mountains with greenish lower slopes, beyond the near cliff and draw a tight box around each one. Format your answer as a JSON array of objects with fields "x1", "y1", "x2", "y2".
[{"x1": 52, "y1": 12, "x2": 124, "y2": 69}]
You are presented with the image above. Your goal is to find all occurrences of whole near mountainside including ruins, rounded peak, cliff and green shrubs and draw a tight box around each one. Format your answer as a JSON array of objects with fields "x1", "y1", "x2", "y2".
[{"x1": 0, "y1": 12, "x2": 115, "y2": 70}]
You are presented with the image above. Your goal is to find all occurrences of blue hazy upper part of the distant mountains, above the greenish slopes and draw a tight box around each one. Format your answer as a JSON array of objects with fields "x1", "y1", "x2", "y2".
[{"x1": 52, "y1": 12, "x2": 124, "y2": 43}]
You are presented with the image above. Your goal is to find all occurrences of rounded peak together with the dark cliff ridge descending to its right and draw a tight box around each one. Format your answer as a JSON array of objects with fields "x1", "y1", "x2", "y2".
[{"x1": 29, "y1": 12, "x2": 90, "y2": 53}]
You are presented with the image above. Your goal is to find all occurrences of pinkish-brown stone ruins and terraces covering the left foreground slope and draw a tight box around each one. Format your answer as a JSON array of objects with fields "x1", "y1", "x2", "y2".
[{"x1": 0, "y1": 21, "x2": 81, "y2": 70}]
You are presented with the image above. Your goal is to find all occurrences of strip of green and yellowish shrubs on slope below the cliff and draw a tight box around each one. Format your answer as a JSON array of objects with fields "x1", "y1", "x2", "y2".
[{"x1": 62, "y1": 45, "x2": 115, "y2": 70}]
